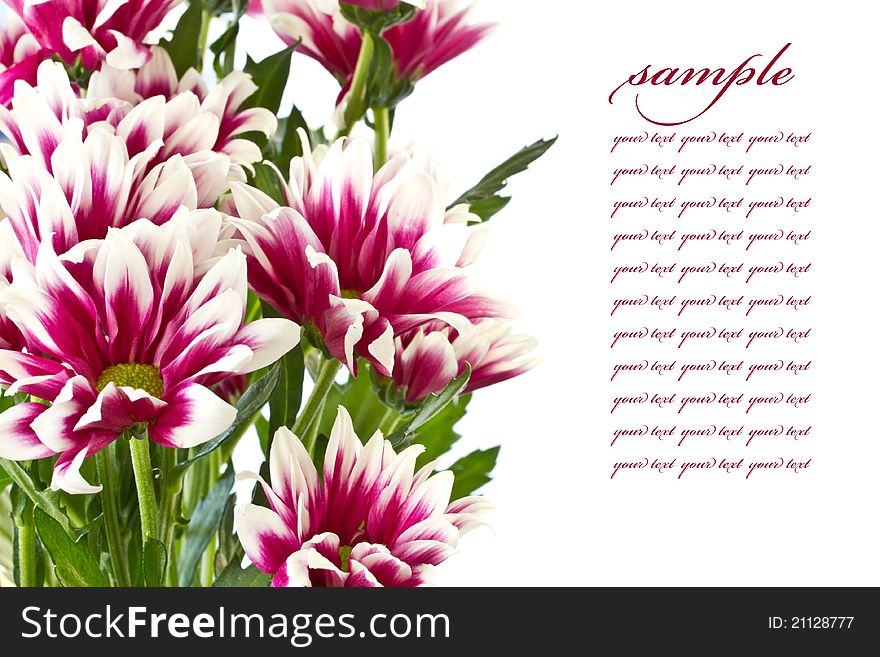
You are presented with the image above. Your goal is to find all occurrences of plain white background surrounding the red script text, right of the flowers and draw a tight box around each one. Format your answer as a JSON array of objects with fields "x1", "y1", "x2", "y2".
[{"x1": 239, "y1": 0, "x2": 880, "y2": 586}]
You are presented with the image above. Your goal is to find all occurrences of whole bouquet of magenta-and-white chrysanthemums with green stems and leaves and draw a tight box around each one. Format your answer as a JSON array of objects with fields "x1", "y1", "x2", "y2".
[{"x1": 0, "y1": 0, "x2": 552, "y2": 586}]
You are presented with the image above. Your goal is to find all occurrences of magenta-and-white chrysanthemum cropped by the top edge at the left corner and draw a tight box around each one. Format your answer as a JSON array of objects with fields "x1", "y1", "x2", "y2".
[{"x1": 3, "y1": 0, "x2": 180, "y2": 70}]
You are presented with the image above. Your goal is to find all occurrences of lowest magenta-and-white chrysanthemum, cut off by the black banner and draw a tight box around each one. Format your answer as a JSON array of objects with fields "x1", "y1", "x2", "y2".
[{"x1": 237, "y1": 407, "x2": 491, "y2": 587}]
